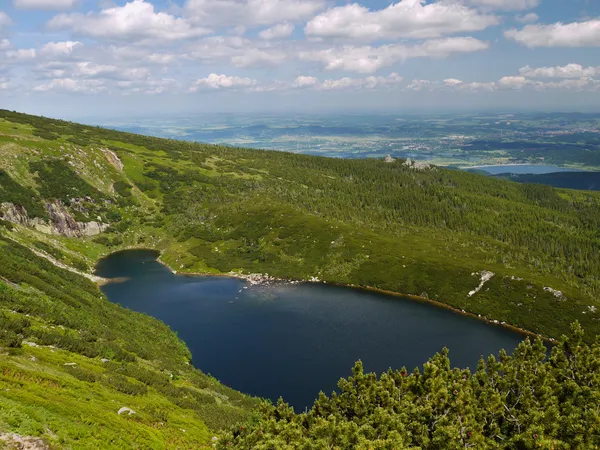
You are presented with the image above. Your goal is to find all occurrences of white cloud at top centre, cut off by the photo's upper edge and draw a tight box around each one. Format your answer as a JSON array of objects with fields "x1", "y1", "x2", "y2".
[{"x1": 184, "y1": 0, "x2": 324, "y2": 27}]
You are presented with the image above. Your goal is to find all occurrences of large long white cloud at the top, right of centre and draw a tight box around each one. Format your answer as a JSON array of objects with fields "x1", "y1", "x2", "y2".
[{"x1": 304, "y1": 0, "x2": 499, "y2": 41}]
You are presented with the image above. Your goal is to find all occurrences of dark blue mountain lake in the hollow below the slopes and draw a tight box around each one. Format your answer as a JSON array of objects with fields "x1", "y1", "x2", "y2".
[{"x1": 97, "y1": 250, "x2": 522, "y2": 410}]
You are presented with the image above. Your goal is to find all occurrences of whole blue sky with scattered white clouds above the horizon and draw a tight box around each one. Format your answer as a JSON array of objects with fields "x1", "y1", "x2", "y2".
[{"x1": 0, "y1": 0, "x2": 600, "y2": 118}]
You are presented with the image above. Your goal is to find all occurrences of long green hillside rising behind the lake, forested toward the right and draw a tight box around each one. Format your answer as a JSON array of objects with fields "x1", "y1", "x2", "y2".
[{"x1": 0, "y1": 111, "x2": 600, "y2": 339}]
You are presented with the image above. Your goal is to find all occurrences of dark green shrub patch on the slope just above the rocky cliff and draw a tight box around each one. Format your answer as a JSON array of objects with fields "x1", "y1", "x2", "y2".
[{"x1": 30, "y1": 159, "x2": 104, "y2": 205}]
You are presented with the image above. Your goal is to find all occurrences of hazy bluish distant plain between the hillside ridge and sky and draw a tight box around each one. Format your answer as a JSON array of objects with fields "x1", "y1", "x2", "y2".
[{"x1": 97, "y1": 113, "x2": 600, "y2": 170}]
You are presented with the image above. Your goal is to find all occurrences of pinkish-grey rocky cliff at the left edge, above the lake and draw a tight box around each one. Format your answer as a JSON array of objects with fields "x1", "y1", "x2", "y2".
[{"x1": 0, "y1": 201, "x2": 108, "y2": 237}]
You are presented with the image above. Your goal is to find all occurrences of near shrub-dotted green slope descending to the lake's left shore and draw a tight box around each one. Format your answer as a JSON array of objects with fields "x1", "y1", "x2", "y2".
[{"x1": 0, "y1": 233, "x2": 257, "y2": 449}]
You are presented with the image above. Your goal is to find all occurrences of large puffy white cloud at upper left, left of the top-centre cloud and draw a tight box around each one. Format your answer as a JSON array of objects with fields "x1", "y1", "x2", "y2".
[{"x1": 48, "y1": 0, "x2": 209, "y2": 41}]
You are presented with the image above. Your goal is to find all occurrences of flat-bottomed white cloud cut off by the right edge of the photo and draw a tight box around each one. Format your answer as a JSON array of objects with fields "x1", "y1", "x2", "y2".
[{"x1": 504, "y1": 20, "x2": 600, "y2": 48}]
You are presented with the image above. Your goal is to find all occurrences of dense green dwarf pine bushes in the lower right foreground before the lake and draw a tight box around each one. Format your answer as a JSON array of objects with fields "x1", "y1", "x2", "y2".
[{"x1": 218, "y1": 325, "x2": 600, "y2": 450}]
